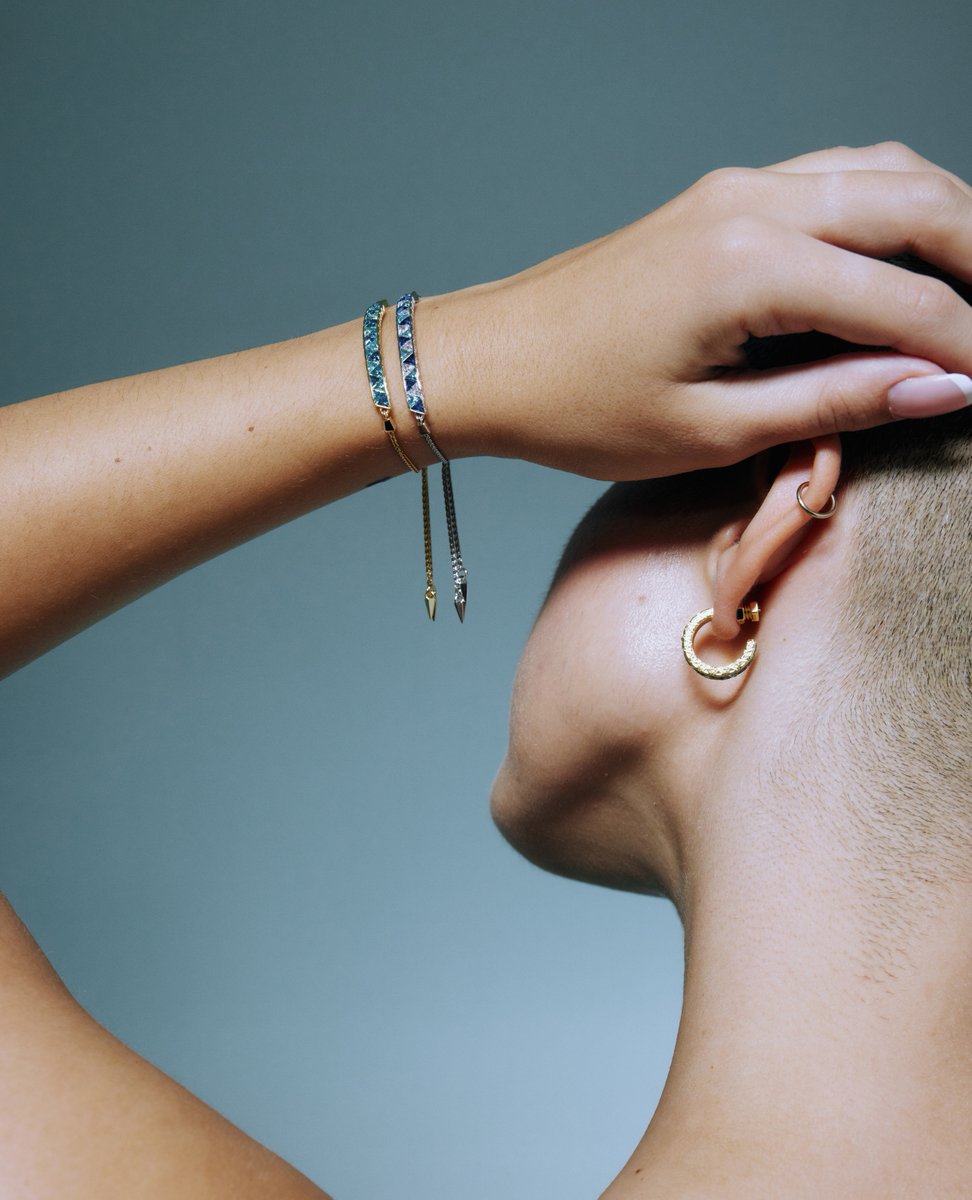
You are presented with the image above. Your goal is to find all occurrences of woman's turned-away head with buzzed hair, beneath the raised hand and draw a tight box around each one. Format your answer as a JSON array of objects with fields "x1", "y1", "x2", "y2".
[{"x1": 493, "y1": 403, "x2": 972, "y2": 895}]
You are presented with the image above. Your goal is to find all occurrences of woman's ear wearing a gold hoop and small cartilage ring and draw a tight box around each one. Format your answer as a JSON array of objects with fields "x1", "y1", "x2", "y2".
[{"x1": 712, "y1": 434, "x2": 840, "y2": 638}]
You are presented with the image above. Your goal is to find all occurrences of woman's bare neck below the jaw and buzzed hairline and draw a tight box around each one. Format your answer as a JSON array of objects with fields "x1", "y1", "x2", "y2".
[{"x1": 606, "y1": 777, "x2": 972, "y2": 1200}]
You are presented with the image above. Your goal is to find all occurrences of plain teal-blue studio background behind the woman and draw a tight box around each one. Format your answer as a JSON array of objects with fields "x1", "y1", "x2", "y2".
[{"x1": 0, "y1": 0, "x2": 972, "y2": 1200}]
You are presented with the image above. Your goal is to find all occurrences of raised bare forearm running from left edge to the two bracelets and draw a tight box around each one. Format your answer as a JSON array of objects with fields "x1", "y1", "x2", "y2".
[{"x1": 0, "y1": 288, "x2": 484, "y2": 673}]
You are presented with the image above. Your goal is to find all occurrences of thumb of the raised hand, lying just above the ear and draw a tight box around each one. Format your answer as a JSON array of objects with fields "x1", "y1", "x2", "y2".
[{"x1": 691, "y1": 354, "x2": 972, "y2": 462}]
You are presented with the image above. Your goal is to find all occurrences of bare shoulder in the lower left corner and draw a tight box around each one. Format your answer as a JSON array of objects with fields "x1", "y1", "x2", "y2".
[{"x1": 0, "y1": 896, "x2": 329, "y2": 1200}]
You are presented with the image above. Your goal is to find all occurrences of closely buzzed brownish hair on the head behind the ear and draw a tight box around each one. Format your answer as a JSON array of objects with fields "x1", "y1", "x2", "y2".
[{"x1": 760, "y1": 260, "x2": 972, "y2": 945}]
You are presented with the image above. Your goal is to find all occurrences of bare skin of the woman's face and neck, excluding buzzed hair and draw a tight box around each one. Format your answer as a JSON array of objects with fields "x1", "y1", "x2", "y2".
[{"x1": 492, "y1": 444, "x2": 972, "y2": 1200}]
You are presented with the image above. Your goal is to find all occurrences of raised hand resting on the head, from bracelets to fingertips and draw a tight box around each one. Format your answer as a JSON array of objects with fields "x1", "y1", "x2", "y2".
[{"x1": 427, "y1": 143, "x2": 972, "y2": 479}]
